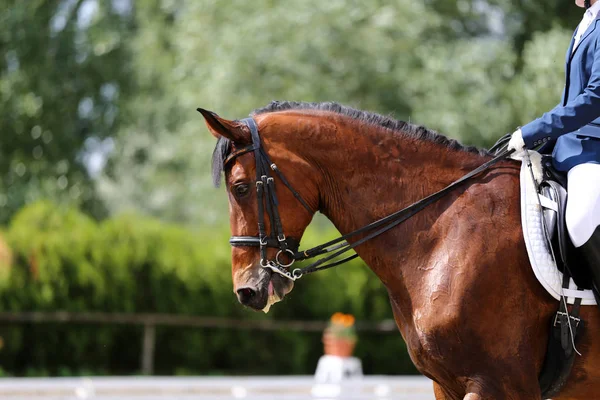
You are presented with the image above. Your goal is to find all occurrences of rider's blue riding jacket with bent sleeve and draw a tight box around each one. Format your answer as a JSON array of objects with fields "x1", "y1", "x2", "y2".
[{"x1": 521, "y1": 19, "x2": 600, "y2": 171}]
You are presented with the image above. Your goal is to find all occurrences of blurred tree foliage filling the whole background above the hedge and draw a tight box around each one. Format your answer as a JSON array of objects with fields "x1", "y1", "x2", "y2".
[{"x1": 0, "y1": 0, "x2": 581, "y2": 225}]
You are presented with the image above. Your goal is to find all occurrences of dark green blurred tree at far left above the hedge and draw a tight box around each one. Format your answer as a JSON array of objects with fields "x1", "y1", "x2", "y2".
[{"x1": 0, "y1": 0, "x2": 131, "y2": 223}]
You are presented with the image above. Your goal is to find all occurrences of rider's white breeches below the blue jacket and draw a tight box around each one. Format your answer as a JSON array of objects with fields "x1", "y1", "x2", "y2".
[{"x1": 565, "y1": 163, "x2": 600, "y2": 247}]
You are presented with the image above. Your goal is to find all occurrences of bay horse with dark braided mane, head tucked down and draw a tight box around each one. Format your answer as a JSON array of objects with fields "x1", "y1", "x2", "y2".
[{"x1": 199, "y1": 102, "x2": 600, "y2": 400}]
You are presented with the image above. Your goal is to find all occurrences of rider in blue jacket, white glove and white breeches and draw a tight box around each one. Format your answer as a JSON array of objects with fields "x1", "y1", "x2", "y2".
[{"x1": 508, "y1": 0, "x2": 600, "y2": 298}]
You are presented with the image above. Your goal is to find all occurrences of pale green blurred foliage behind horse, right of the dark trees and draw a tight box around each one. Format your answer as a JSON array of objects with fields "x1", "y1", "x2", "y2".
[{"x1": 97, "y1": 0, "x2": 581, "y2": 224}]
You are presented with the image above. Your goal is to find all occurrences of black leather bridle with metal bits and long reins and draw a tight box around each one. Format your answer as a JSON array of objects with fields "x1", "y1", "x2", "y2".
[{"x1": 223, "y1": 118, "x2": 513, "y2": 281}]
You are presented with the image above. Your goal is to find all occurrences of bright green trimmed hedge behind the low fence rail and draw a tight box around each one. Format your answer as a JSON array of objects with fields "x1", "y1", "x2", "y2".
[{"x1": 0, "y1": 202, "x2": 414, "y2": 375}]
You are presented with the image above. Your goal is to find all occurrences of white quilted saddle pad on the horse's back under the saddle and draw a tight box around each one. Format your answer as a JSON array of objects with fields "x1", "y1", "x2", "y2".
[{"x1": 521, "y1": 155, "x2": 596, "y2": 305}]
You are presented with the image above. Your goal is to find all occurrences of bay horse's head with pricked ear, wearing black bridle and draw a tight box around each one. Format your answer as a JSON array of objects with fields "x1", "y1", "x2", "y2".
[{"x1": 198, "y1": 109, "x2": 319, "y2": 312}]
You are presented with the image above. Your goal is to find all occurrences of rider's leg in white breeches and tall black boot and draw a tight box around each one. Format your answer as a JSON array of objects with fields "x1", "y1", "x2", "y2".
[{"x1": 566, "y1": 163, "x2": 600, "y2": 294}]
